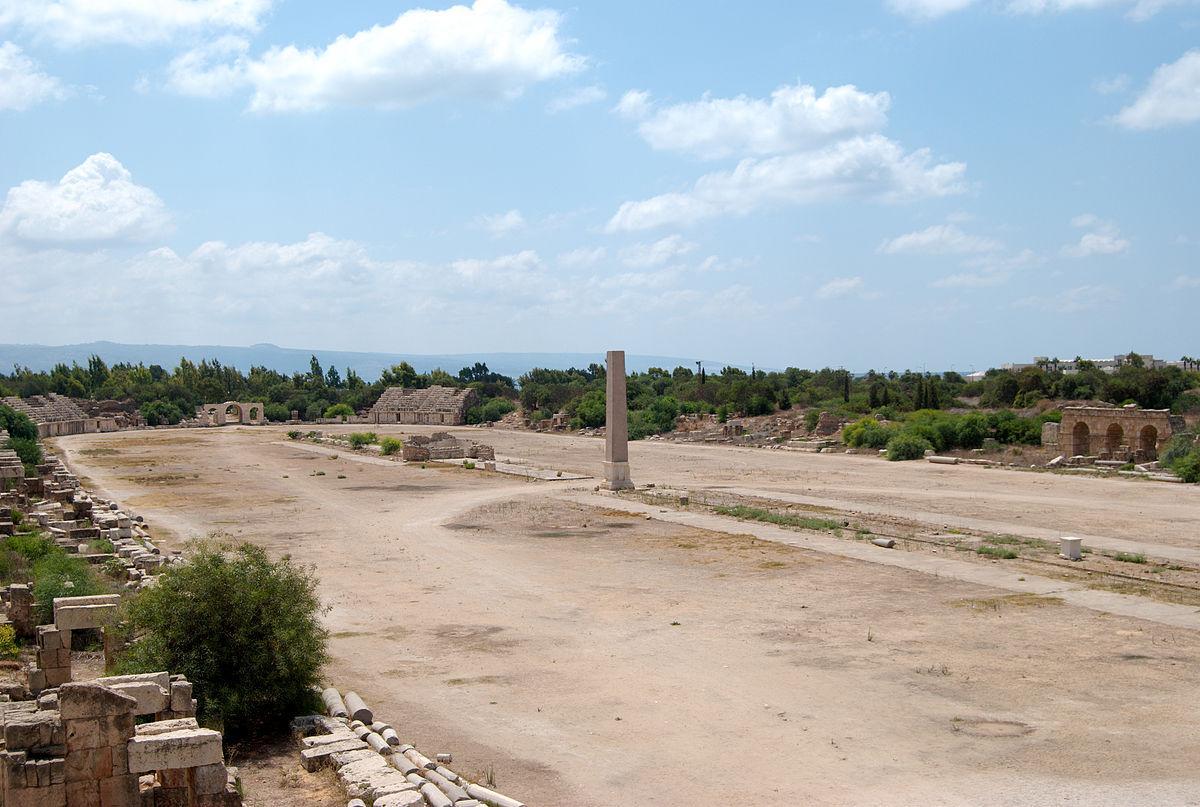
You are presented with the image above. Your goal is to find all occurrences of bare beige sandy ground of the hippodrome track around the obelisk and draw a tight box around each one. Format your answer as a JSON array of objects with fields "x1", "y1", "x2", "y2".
[{"x1": 51, "y1": 429, "x2": 1200, "y2": 807}]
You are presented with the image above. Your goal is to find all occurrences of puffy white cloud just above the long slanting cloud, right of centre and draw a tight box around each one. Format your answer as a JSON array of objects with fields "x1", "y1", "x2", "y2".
[{"x1": 618, "y1": 84, "x2": 892, "y2": 160}]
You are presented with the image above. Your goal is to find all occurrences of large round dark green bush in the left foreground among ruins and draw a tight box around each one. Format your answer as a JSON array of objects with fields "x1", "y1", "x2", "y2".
[{"x1": 120, "y1": 544, "x2": 328, "y2": 739}]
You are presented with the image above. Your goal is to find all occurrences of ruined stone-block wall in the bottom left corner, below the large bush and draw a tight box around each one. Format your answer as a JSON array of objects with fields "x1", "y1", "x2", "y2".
[{"x1": 0, "y1": 673, "x2": 241, "y2": 807}]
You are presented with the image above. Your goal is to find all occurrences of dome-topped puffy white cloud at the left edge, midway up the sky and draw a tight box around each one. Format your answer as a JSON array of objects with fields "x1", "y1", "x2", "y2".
[{"x1": 0, "y1": 153, "x2": 170, "y2": 245}]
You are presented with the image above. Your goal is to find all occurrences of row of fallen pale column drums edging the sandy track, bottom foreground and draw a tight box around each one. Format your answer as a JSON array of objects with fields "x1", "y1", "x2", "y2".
[{"x1": 320, "y1": 687, "x2": 526, "y2": 807}]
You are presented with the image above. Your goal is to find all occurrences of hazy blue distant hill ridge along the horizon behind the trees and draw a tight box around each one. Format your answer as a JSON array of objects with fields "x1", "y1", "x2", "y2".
[{"x1": 0, "y1": 342, "x2": 739, "y2": 381}]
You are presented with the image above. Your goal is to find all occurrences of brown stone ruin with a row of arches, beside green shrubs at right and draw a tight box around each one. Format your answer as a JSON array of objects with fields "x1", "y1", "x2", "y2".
[{"x1": 1058, "y1": 405, "x2": 1181, "y2": 462}]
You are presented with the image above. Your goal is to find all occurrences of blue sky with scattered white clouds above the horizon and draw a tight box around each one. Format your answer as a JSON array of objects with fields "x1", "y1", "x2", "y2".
[{"x1": 0, "y1": 0, "x2": 1200, "y2": 370}]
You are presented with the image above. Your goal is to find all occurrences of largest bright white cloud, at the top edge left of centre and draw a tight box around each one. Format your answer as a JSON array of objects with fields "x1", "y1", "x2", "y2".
[{"x1": 173, "y1": 0, "x2": 584, "y2": 112}]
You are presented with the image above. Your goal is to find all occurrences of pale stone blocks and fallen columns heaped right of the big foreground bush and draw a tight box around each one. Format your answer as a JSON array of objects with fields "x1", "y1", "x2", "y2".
[{"x1": 292, "y1": 687, "x2": 524, "y2": 807}]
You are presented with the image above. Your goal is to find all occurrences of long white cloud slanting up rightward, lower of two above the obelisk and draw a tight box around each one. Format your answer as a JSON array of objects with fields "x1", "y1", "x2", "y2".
[{"x1": 607, "y1": 135, "x2": 966, "y2": 232}]
